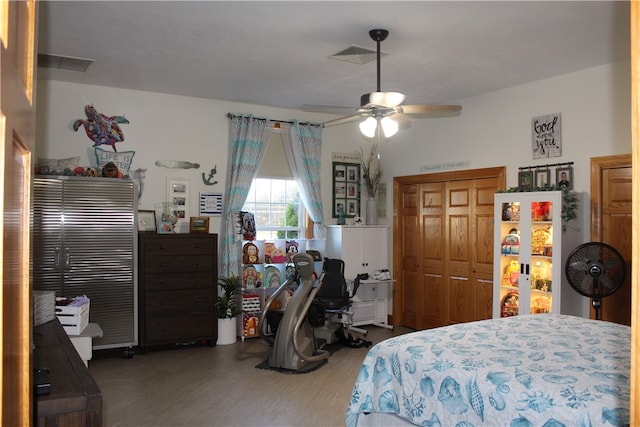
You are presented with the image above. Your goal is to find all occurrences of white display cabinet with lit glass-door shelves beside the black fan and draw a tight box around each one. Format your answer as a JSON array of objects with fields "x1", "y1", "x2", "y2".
[{"x1": 493, "y1": 191, "x2": 588, "y2": 318}]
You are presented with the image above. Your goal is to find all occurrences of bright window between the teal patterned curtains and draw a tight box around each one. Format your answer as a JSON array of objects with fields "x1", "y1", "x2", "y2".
[{"x1": 242, "y1": 178, "x2": 304, "y2": 240}]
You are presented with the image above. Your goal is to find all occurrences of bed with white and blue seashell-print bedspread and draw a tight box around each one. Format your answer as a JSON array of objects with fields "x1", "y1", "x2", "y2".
[{"x1": 345, "y1": 314, "x2": 631, "y2": 427}]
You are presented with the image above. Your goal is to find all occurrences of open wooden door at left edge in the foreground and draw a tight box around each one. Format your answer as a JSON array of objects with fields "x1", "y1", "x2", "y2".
[{"x1": 0, "y1": 0, "x2": 36, "y2": 426}]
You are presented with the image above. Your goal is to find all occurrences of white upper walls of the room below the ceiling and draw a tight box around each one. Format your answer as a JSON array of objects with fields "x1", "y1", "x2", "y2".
[{"x1": 36, "y1": 57, "x2": 631, "y2": 318}]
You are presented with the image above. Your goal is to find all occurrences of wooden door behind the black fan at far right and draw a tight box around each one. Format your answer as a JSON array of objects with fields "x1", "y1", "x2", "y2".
[{"x1": 591, "y1": 154, "x2": 633, "y2": 326}]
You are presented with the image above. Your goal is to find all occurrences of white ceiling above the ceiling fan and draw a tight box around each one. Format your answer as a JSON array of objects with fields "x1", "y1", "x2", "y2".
[{"x1": 38, "y1": 1, "x2": 630, "y2": 109}]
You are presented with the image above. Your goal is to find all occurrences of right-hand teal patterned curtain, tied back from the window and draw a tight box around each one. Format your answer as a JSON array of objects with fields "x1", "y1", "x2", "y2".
[{"x1": 282, "y1": 120, "x2": 326, "y2": 239}]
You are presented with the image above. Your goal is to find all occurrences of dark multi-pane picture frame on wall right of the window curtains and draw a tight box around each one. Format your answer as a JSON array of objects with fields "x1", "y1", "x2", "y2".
[{"x1": 331, "y1": 162, "x2": 361, "y2": 218}]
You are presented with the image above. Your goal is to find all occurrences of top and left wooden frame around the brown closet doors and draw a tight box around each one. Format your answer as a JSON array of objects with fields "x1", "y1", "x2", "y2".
[{"x1": 391, "y1": 166, "x2": 507, "y2": 325}]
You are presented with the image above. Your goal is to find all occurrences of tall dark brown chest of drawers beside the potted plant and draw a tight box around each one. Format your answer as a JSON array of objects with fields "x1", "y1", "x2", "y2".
[{"x1": 138, "y1": 232, "x2": 218, "y2": 352}]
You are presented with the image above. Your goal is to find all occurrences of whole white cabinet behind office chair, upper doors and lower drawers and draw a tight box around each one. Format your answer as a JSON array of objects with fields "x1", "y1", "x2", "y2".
[{"x1": 326, "y1": 226, "x2": 391, "y2": 327}]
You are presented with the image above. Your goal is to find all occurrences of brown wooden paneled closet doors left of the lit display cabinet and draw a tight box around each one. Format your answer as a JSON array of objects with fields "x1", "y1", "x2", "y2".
[{"x1": 393, "y1": 168, "x2": 505, "y2": 329}]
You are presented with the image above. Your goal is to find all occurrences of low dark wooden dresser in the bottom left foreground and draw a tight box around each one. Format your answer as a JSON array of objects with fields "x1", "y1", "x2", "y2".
[{"x1": 34, "y1": 319, "x2": 102, "y2": 427}]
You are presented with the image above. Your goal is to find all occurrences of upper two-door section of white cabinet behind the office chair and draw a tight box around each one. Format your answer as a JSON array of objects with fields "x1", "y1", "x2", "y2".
[{"x1": 326, "y1": 225, "x2": 389, "y2": 280}]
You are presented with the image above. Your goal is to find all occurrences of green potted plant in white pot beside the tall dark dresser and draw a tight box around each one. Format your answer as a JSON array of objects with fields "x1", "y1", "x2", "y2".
[{"x1": 216, "y1": 276, "x2": 242, "y2": 345}]
